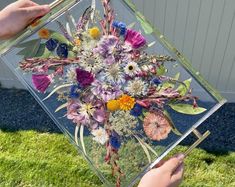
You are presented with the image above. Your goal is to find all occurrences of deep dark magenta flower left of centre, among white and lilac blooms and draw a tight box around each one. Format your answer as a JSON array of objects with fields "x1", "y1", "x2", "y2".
[{"x1": 76, "y1": 68, "x2": 94, "y2": 88}]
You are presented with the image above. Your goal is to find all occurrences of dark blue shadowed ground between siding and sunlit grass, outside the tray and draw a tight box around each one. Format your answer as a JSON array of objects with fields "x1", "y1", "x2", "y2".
[{"x1": 0, "y1": 89, "x2": 235, "y2": 154}]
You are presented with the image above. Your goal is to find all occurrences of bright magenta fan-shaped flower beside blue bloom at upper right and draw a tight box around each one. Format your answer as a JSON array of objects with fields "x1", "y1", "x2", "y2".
[{"x1": 125, "y1": 29, "x2": 146, "y2": 49}]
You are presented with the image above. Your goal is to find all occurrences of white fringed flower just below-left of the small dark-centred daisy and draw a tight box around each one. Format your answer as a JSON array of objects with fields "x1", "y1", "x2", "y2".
[{"x1": 103, "y1": 63, "x2": 125, "y2": 84}]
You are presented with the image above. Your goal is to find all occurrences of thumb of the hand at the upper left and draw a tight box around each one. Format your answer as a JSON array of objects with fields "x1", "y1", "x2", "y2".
[{"x1": 22, "y1": 5, "x2": 50, "y2": 20}]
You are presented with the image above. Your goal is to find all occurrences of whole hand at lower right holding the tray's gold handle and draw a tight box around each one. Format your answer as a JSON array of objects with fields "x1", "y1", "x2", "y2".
[{"x1": 138, "y1": 154, "x2": 184, "y2": 187}]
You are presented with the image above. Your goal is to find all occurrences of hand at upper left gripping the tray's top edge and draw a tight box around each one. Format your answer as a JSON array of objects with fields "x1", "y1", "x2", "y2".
[{"x1": 0, "y1": 0, "x2": 50, "y2": 39}]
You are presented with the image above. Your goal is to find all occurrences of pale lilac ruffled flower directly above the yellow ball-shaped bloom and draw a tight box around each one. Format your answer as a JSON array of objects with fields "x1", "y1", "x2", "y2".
[{"x1": 91, "y1": 81, "x2": 122, "y2": 102}]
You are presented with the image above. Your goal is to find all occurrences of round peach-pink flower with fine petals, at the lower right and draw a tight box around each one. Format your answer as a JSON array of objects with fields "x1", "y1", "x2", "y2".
[{"x1": 143, "y1": 112, "x2": 171, "y2": 141}]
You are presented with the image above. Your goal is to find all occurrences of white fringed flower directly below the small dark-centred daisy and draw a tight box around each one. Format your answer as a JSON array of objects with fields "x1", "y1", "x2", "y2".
[{"x1": 126, "y1": 78, "x2": 147, "y2": 96}]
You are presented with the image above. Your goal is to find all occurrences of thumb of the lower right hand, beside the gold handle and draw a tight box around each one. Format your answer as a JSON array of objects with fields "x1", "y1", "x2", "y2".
[{"x1": 160, "y1": 154, "x2": 184, "y2": 174}]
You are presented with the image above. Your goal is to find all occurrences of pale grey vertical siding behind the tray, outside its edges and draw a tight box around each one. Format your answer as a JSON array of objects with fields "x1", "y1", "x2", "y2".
[{"x1": 0, "y1": 0, "x2": 235, "y2": 101}]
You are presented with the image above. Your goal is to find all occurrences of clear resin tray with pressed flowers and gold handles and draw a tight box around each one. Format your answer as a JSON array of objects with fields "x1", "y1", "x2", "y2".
[{"x1": 1, "y1": 0, "x2": 225, "y2": 186}]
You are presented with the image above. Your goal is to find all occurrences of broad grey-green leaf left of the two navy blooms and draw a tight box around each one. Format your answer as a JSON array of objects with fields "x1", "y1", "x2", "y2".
[{"x1": 17, "y1": 39, "x2": 41, "y2": 58}]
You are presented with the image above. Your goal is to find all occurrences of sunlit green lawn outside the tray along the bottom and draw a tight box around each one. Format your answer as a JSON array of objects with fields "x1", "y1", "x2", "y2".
[{"x1": 0, "y1": 131, "x2": 235, "y2": 187}]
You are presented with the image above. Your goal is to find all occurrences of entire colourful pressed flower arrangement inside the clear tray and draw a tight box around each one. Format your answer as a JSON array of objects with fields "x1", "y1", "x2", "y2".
[{"x1": 12, "y1": 0, "x2": 211, "y2": 186}]
